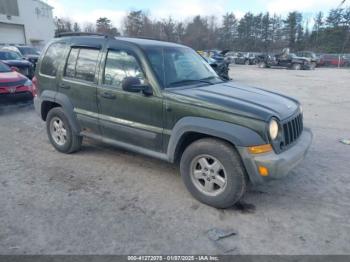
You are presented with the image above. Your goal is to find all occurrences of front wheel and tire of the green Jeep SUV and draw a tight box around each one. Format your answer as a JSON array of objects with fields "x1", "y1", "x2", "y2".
[{"x1": 180, "y1": 138, "x2": 247, "y2": 208}]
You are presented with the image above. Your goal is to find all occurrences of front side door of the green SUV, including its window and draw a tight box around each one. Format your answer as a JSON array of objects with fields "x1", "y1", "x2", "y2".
[{"x1": 97, "y1": 44, "x2": 163, "y2": 151}]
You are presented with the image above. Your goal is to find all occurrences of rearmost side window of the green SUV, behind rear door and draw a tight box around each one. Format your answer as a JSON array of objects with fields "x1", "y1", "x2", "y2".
[{"x1": 40, "y1": 43, "x2": 65, "y2": 76}]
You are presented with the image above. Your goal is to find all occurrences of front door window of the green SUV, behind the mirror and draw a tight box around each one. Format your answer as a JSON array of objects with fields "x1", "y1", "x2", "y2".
[{"x1": 103, "y1": 50, "x2": 145, "y2": 89}]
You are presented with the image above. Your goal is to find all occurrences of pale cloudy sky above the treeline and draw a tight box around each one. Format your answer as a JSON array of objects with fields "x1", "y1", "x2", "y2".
[{"x1": 43, "y1": 0, "x2": 341, "y2": 27}]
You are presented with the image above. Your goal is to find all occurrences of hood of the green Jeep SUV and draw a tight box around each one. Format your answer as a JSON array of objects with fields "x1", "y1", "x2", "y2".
[{"x1": 168, "y1": 82, "x2": 299, "y2": 121}]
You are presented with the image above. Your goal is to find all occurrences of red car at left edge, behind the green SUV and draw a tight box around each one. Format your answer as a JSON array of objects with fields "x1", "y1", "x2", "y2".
[{"x1": 0, "y1": 62, "x2": 35, "y2": 101}]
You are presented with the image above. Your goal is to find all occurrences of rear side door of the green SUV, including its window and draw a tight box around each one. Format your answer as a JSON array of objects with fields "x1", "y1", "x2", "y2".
[{"x1": 58, "y1": 42, "x2": 102, "y2": 134}]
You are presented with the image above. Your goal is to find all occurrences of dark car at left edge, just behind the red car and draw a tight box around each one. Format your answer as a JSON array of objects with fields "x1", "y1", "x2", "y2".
[{"x1": 0, "y1": 50, "x2": 34, "y2": 79}]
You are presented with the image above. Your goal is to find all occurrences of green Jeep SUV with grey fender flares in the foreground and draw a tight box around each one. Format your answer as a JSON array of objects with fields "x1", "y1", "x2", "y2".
[{"x1": 34, "y1": 35, "x2": 312, "y2": 208}]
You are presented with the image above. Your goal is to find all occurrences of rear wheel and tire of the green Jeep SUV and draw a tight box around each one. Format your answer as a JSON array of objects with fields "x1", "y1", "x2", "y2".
[{"x1": 46, "y1": 107, "x2": 83, "y2": 154}]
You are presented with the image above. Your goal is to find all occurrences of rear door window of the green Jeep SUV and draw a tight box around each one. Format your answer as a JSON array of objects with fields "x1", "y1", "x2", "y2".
[{"x1": 64, "y1": 48, "x2": 99, "y2": 82}]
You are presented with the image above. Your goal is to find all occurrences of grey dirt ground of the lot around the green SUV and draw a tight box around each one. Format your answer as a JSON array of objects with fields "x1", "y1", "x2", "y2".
[{"x1": 0, "y1": 66, "x2": 350, "y2": 254}]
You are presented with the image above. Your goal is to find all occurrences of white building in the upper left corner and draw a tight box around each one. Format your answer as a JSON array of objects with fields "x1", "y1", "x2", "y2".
[{"x1": 0, "y1": 0, "x2": 55, "y2": 48}]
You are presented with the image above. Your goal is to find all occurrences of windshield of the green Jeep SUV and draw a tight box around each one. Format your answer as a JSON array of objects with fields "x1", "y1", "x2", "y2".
[{"x1": 145, "y1": 47, "x2": 219, "y2": 88}]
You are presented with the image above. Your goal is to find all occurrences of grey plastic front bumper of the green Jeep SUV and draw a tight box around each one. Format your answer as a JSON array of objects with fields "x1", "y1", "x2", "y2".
[{"x1": 237, "y1": 128, "x2": 313, "y2": 184}]
